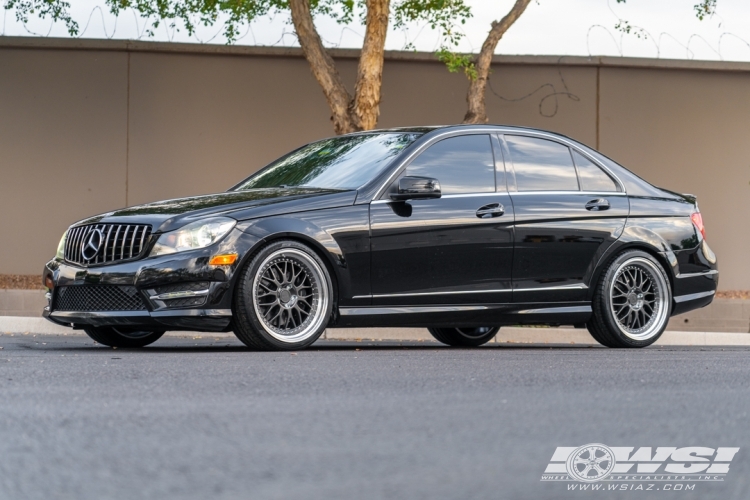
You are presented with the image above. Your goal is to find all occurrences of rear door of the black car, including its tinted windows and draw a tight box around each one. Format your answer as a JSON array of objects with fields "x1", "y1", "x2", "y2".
[{"x1": 501, "y1": 135, "x2": 629, "y2": 302}]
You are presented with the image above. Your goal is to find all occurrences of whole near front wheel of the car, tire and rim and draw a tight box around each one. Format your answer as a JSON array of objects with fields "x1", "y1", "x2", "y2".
[{"x1": 234, "y1": 240, "x2": 334, "y2": 351}]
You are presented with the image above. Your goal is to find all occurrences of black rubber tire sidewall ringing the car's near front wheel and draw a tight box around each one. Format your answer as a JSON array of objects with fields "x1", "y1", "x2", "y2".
[{"x1": 236, "y1": 240, "x2": 334, "y2": 350}]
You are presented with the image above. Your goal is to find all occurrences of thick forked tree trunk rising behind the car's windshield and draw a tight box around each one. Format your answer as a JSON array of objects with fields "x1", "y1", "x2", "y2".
[{"x1": 289, "y1": 0, "x2": 390, "y2": 134}]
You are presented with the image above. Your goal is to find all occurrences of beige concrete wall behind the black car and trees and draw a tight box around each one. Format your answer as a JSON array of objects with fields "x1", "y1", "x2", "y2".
[{"x1": 0, "y1": 37, "x2": 750, "y2": 290}]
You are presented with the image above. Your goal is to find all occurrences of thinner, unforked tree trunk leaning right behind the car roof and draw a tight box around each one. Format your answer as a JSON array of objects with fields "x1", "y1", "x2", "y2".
[{"x1": 464, "y1": 0, "x2": 531, "y2": 123}]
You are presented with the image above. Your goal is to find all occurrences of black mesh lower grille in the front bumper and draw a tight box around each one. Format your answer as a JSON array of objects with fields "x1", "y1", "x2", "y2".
[{"x1": 52, "y1": 285, "x2": 146, "y2": 311}]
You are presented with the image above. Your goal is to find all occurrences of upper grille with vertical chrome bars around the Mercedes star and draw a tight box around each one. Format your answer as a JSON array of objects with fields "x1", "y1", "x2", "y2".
[{"x1": 65, "y1": 224, "x2": 151, "y2": 266}]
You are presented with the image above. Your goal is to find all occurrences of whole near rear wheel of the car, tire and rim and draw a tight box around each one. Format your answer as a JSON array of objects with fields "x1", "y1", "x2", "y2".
[{"x1": 586, "y1": 250, "x2": 672, "y2": 347}]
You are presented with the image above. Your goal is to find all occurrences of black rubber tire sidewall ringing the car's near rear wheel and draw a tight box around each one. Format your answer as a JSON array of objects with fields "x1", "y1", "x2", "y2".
[{"x1": 599, "y1": 250, "x2": 672, "y2": 347}]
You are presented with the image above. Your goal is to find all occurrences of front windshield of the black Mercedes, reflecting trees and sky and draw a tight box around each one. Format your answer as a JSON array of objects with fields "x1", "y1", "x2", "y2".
[{"x1": 233, "y1": 132, "x2": 422, "y2": 191}]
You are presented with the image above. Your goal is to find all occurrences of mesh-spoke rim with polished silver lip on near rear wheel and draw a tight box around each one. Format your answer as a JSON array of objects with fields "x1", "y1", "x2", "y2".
[{"x1": 608, "y1": 257, "x2": 670, "y2": 341}]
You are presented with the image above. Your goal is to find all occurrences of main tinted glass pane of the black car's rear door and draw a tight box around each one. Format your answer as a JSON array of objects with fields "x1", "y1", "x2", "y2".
[{"x1": 505, "y1": 135, "x2": 578, "y2": 191}]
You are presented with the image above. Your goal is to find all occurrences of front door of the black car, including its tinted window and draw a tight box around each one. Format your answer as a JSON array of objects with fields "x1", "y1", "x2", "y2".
[{"x1": 370, "y1": 134, "x2": 513, "y2": 305}]
